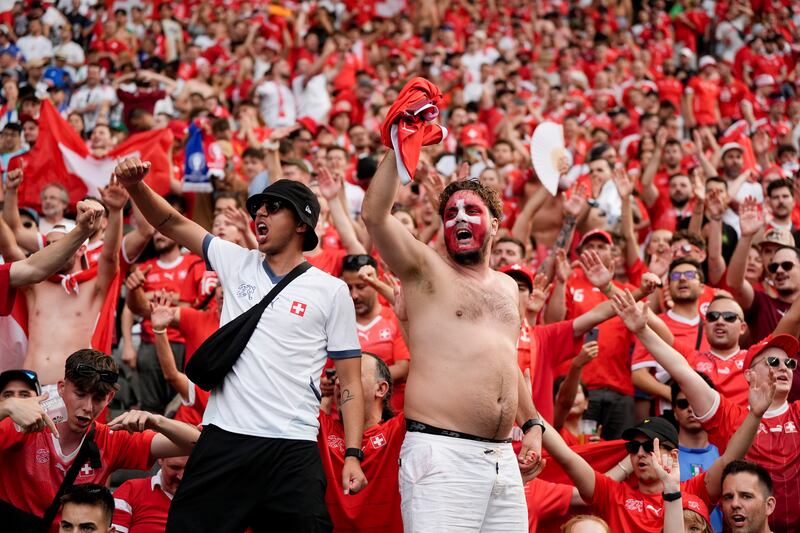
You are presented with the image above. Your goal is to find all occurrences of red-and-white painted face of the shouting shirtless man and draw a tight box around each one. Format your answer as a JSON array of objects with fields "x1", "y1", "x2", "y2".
[{"x1": 444, "y1": 191, "x2": 489, "y2": 254}]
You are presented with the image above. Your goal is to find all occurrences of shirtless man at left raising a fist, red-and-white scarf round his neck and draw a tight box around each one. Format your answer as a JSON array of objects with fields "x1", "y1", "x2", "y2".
[{"x1": 24, "y1": 177, "x2": 128, "y2": 385}]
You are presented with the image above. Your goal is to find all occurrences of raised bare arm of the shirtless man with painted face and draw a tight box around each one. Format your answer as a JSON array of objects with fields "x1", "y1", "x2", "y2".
[{"x1": 361, "y1": 150, "x2": 434, "y2": 280}]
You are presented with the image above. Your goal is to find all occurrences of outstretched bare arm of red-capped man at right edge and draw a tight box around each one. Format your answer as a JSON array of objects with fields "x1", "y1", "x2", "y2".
[{"x1": 612, "y1": 290, "x2": 717, "y2": 413}]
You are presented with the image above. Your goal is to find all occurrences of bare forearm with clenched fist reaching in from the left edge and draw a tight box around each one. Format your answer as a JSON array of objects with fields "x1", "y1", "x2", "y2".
[{"x1": 11, "y1": 200, "x2": 103, "y2": 287}]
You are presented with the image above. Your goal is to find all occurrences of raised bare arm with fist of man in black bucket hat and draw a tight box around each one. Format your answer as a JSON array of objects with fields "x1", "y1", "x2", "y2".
[{"x1": 114, "y1": 157, "x2": 208, "y2": 257}]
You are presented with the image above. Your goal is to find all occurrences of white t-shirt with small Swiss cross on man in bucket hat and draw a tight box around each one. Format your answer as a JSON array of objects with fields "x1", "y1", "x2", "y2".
[{"x1": 203, "y1": 235, "x2": 361, "y2": 441}]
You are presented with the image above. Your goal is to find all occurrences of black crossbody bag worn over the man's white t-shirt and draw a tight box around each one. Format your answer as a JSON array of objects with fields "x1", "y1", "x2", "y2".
[{"x1": 186, "y1": 261, "x2": 311, "y2": 391}]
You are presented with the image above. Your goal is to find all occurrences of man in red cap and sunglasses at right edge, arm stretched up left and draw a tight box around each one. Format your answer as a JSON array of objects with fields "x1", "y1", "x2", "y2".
[{"x1": 615, "y1": 286, "x2": 800, "y2": 531}]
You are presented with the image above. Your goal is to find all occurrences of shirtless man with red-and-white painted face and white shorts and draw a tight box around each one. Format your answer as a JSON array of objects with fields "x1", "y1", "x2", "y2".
[{"x1": 362, "y1": 151, "x2": 542, "y2": 532}]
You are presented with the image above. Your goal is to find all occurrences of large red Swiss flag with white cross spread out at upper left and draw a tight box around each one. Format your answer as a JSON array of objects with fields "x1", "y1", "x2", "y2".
[{"x1": 19, "y1": 100, "x2": 172, "y2": 209}]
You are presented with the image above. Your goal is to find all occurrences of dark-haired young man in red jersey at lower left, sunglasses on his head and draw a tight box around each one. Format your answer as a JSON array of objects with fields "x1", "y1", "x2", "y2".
[{"x1": 0, "y1": 349, "x2": 200, "y2": 531}]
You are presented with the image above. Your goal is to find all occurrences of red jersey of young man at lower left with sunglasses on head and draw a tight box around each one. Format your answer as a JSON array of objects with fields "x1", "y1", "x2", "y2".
[{"x1": 0, "y1": 418, "x2": 156, "y2": 516}]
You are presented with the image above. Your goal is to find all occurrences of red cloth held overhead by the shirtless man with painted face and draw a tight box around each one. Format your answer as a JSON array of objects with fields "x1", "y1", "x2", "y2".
[{"x1": 381, "y1": 77, "x2": 447, "y2": 184}]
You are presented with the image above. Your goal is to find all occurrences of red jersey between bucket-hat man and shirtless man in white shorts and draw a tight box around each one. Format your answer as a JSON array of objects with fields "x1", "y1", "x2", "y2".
[{"x1": 317, "y1": 413, "x2": 406, "y2": 533}]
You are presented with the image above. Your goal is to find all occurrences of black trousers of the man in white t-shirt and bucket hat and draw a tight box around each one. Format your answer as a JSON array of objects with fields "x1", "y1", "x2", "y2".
[{"x1": 166, "y1": 425, "x2": 333, "y2": 533}]
